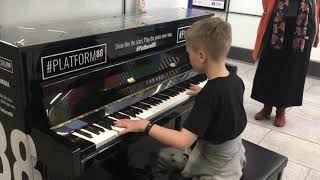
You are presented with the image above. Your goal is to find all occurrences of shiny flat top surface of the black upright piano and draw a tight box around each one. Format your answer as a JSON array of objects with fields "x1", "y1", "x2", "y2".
[{"x1": 0, "y1": 8, "x2": 212, "y2": 47}]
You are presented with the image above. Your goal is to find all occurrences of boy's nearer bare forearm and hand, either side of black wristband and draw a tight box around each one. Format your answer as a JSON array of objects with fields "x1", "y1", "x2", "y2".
[{"x1": 115, "y1": 120, "x2": 198, "y2": 151}]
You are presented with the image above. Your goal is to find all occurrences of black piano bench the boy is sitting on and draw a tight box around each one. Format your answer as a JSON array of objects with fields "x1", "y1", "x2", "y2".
[{"x1": 169, "y1": 140, "x2": 288, "y2": 180}]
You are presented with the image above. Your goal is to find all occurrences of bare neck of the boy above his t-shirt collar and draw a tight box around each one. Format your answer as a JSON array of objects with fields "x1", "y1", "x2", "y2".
[{"x1": 206, "y1": 60, "x2": 229, "y2": 80}]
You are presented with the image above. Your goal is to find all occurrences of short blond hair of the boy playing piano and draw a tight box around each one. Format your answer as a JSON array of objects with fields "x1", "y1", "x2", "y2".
[{"x1": 186, "y1": 17, "x2": 232, "y2": 60}]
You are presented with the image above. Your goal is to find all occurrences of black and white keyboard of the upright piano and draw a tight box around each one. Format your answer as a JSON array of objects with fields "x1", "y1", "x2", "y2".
[{"x1": 72, "y1": 76, "x2": 207, "y2": 148}]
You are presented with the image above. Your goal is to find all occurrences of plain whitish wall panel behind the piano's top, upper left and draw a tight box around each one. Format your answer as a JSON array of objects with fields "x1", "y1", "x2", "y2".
[{"x1": 0, "y1": 0, "x2": 122, "y2": 26}]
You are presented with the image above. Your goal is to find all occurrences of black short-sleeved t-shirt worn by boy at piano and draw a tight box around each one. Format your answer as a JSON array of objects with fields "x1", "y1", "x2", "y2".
[{"x1": 183, "y1": 73, "x2": 247, "y2": 144}]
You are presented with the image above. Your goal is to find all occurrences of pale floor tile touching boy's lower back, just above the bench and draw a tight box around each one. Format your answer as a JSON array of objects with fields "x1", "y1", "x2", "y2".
[{"x1": 242, "y1": 122, "x2": 271, "y2": 144}]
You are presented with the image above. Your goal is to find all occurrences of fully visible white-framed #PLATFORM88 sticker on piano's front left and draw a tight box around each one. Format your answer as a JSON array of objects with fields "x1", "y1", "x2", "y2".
[{"x1": 41, "y1": 44, "x2": 107, "y2": 80}]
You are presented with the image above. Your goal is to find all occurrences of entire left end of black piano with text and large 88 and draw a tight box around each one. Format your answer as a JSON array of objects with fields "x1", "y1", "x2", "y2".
[{"x1": 0, "y1": 42, "x2": 42, "y2": 180}]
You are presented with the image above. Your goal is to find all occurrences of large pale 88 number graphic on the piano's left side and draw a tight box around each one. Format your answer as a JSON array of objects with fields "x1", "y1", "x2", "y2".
[{"x1": 0, "y1": 123, "x2": 42, "y2": 180}]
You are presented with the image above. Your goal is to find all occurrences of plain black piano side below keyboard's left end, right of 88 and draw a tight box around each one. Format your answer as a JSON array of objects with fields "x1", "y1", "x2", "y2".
[{"x1": 31, "y1": 129, "x2": 81, "y2": 180}]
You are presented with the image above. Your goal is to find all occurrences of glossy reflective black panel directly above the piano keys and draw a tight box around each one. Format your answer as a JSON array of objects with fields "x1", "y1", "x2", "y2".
[{"x1": 43, "y1": 47, "x2": 190, "y2": 125}]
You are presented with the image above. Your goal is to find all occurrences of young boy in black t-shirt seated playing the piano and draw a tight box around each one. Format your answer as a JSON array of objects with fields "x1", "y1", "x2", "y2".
[{"x1": 115, "y1": 18, "x2": 247, "y2": 180}]
